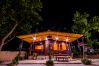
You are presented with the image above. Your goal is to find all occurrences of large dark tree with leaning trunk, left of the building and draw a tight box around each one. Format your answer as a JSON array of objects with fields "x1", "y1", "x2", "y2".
[{"x1": 0, "y1": 0, "x2": 42, "y2": 51}]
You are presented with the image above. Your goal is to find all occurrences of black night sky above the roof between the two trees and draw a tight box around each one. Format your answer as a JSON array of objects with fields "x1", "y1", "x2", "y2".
[{"x1": 35, "y1": 0, "x2": 99, "y2": 32}]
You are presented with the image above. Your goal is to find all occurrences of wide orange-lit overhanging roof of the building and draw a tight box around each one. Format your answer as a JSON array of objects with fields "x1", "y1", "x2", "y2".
[{"x1": 17, "y1": 31, "x2": 83, "y2": 44}]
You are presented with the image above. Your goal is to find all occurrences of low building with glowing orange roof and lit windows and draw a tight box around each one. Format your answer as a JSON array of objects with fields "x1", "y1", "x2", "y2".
[{"x1": 17, "y1": 31, "x2": 83, "y2": 55}]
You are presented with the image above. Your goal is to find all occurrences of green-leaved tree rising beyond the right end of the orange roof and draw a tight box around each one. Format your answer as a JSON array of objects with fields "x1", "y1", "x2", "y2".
[{"x1": 72, "y1": 11, "x2": 99, "y2": 45}]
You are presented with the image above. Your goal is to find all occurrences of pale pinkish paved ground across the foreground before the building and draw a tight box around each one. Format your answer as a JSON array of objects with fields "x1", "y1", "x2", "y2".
[{"x1": 0, "y1": 59, "x2": 99, "y2": 66}]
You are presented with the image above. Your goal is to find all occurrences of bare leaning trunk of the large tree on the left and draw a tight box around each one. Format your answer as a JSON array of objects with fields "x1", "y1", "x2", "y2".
[{"x1": 0, "y1": 22, "x2": 18, "y2": 51}]
